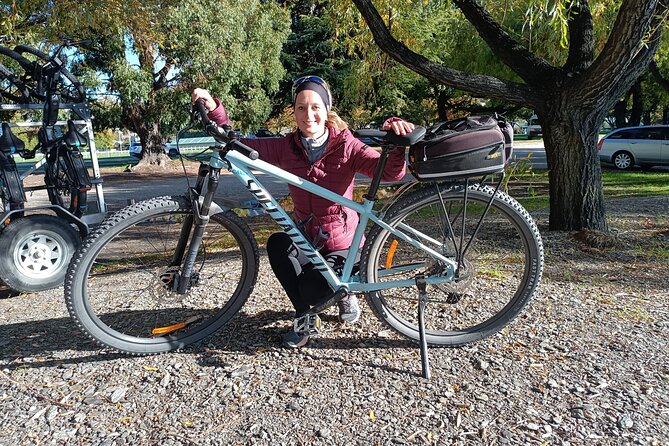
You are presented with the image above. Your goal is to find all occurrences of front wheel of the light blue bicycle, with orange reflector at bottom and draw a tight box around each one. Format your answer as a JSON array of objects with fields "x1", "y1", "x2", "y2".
[{"x1": 65, "y1": 197, "x2": 258, "y2": 354}]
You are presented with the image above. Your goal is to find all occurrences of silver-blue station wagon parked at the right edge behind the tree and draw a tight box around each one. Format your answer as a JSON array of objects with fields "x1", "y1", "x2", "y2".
[{"x1": 597, "y1": 125, "x2": 669, "y2": 170}]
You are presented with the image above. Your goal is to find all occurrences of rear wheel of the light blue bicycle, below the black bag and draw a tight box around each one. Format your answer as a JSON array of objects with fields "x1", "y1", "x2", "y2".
[{"x1": 361, "y1": 184, "x2": 543, "y2": 347}]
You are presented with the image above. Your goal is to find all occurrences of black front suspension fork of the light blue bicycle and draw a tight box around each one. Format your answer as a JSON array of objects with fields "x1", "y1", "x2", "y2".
[{"x1": 173, "y1": 165, "x2": 221, "y2": 294}]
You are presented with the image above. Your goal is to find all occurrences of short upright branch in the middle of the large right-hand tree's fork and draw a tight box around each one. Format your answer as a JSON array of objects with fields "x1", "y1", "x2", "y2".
[{"x1": 563, "y1": 0, "x2": 595, "y2": 73}]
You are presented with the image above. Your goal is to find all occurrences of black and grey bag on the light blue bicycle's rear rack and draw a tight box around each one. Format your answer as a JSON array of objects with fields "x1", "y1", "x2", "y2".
[{"x1": 409, "y1": 116, "x2": 513, "y2": 181}]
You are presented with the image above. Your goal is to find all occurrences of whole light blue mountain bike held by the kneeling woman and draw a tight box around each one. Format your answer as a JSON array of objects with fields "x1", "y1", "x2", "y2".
[{"x1": 65, "y1": 102, "x2": 543, "y2": 376}]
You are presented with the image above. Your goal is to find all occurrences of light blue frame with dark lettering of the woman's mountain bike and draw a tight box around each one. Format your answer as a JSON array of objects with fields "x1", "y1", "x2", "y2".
[{"x1": 209, "y1": 146, "x2": 457, "y2": 292}]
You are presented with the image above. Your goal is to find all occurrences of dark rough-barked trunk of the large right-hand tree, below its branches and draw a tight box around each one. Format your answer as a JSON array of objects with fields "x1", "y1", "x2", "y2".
[{"x1": 537, "y1": 103, "x2": 607, "y2": 231}]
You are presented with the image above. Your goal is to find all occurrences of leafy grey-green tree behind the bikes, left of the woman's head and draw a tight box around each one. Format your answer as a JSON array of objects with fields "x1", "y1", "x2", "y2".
[{"x1": 89, "y1": 0, "x2": 288, "y2": 162}]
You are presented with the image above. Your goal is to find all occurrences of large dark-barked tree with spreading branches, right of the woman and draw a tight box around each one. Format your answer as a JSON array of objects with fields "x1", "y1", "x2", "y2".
[{"x1": 353, "y1": 0, "x2": 666, "y2": 230}]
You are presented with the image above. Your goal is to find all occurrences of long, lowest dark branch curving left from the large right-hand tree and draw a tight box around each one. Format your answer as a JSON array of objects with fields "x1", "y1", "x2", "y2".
[{"x1": 353, "y1": 0, "x2": 537, "y2": 105}]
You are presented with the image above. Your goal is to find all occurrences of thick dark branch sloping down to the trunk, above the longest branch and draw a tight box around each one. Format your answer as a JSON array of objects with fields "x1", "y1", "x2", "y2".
[{"x1": 446, "y1": 0, "x2": 562, "y2": 85}]
